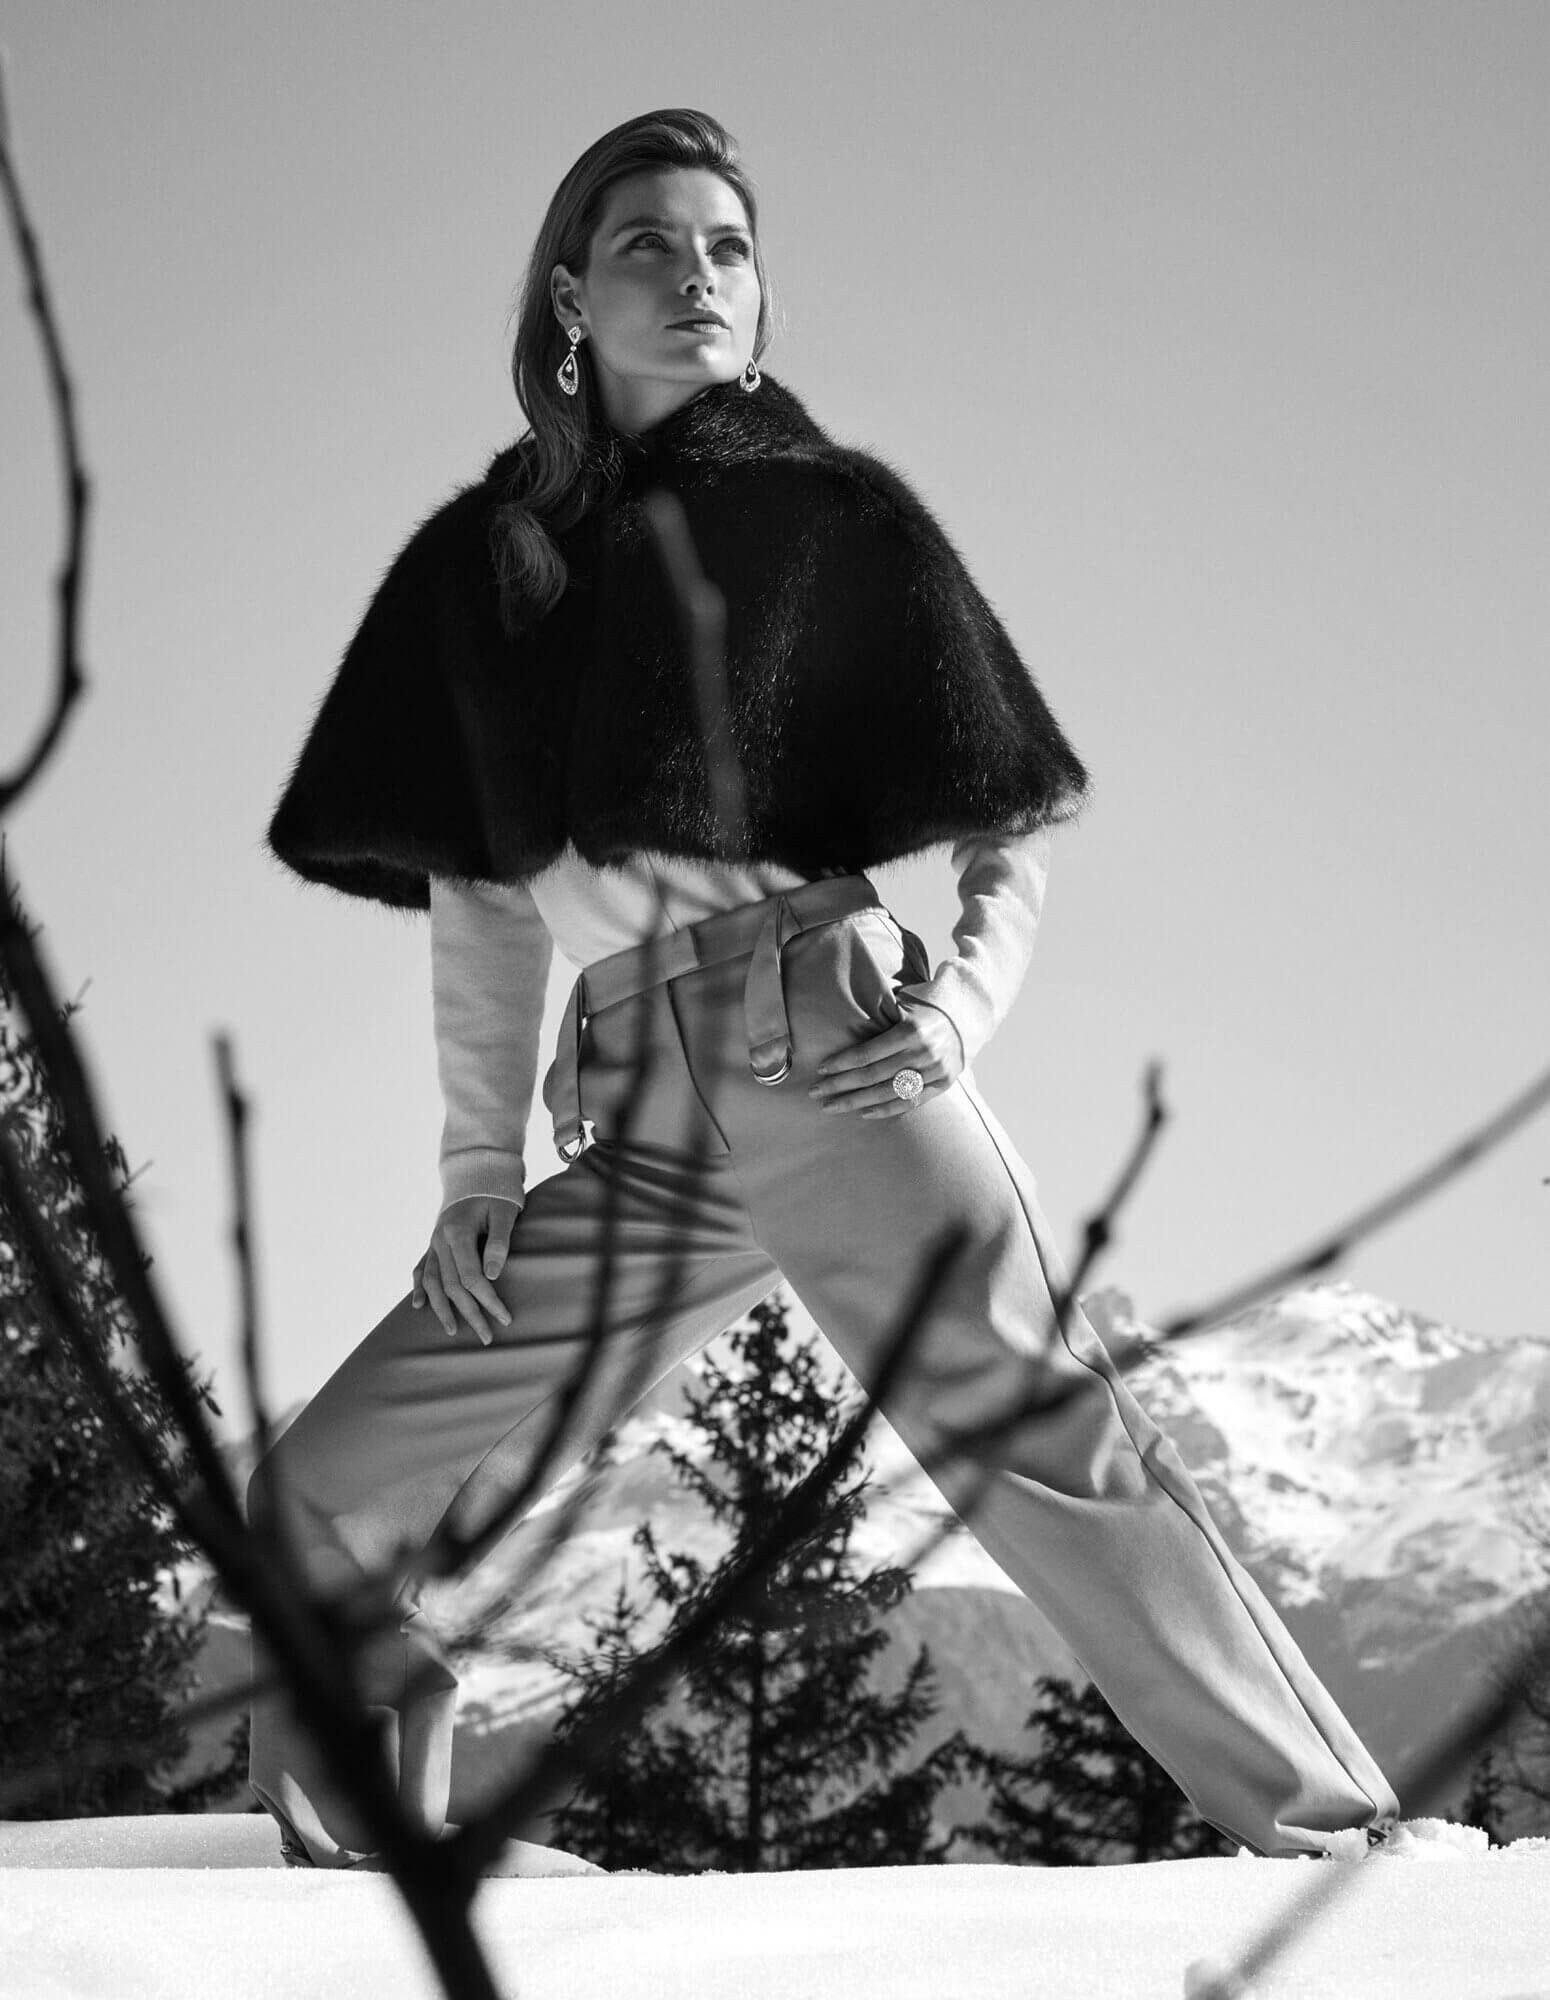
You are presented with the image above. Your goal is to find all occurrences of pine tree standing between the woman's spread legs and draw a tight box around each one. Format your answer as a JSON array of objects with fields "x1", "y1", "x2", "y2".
[{"x1": 550, "y1": 1300, "x2": 984, "y2": 1874}]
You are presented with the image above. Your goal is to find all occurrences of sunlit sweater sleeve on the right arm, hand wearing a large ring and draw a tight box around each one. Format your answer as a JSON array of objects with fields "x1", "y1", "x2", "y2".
[{"x1": 900, "y1": 826, "x2": 1050, "y2": 1064}]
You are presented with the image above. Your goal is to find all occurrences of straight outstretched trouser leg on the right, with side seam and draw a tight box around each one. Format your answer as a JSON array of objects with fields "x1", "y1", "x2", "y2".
[{"x1": 690, "y1": 918, "x2": 1398, "y2": 1854}]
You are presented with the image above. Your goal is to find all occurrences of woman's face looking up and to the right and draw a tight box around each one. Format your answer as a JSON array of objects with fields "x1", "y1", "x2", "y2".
[{"x1": 550, "y1": 166, "x2": 760, "y2": 432}]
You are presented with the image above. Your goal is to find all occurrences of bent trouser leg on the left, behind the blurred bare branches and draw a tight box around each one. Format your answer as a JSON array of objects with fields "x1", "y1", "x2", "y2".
[{"x1": 250, "y1": 1040, "x2": 776, "y2": 1866}]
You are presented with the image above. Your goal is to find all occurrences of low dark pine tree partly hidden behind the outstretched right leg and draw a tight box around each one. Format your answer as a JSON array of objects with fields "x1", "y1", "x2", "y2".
[{"x1": 968, "y1": 1674, "x2": 1236, "y2": 1868}]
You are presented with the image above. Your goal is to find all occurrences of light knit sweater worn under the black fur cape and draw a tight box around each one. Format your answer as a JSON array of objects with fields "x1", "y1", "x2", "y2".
[{"x1": 430, "y1": 828, "x2": 1050, "y2": 1210}]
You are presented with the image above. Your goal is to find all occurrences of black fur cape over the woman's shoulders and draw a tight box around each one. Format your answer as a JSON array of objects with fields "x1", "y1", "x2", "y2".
[{"x1": 270, "y1": 374, "x2": 1088, "y2": 908}]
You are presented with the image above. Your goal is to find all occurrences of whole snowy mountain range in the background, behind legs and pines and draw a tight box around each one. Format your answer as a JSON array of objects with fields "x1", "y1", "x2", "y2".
[{"x1": 191, "y1": 1284, "x2": 1550, "y2": 1838}]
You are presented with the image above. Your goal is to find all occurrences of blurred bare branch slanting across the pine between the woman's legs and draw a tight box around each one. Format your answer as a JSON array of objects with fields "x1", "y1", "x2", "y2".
[{"x1": 448, "y1": 1228, "x2": 966, "y2": 1878}]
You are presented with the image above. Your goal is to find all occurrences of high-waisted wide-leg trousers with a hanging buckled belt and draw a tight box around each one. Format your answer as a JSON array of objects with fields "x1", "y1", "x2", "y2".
[{"x1": 248, "y1": 876, "x2": 1398, "y2": 1866}]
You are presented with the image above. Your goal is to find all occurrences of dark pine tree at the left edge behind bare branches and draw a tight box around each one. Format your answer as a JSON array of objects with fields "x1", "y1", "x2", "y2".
[{"x1": 0, "y1": 872, "x2": 240, "y2": 1818}]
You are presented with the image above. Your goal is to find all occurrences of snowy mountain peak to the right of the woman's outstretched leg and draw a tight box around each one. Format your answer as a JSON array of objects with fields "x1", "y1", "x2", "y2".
[{"x1": 1088, "y1": 1284, "x2": 1550, "y2": 1808}]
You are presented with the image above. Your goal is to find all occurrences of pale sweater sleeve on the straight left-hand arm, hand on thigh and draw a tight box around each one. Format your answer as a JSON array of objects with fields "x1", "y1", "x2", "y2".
[{"x1": 430, "y1": 876, "x2": 554, "y2": 1210}]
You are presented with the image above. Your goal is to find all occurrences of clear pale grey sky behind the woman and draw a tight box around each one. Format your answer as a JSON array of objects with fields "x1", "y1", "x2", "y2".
[{"x1": 0, "y1": 0, "x2": 1550, "y2": 1422}]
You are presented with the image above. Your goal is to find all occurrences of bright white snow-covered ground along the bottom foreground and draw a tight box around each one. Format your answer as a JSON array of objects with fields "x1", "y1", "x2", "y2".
[{"x1": 0, "y1": 1814, "x2": 1550, "y2": 2000}]
